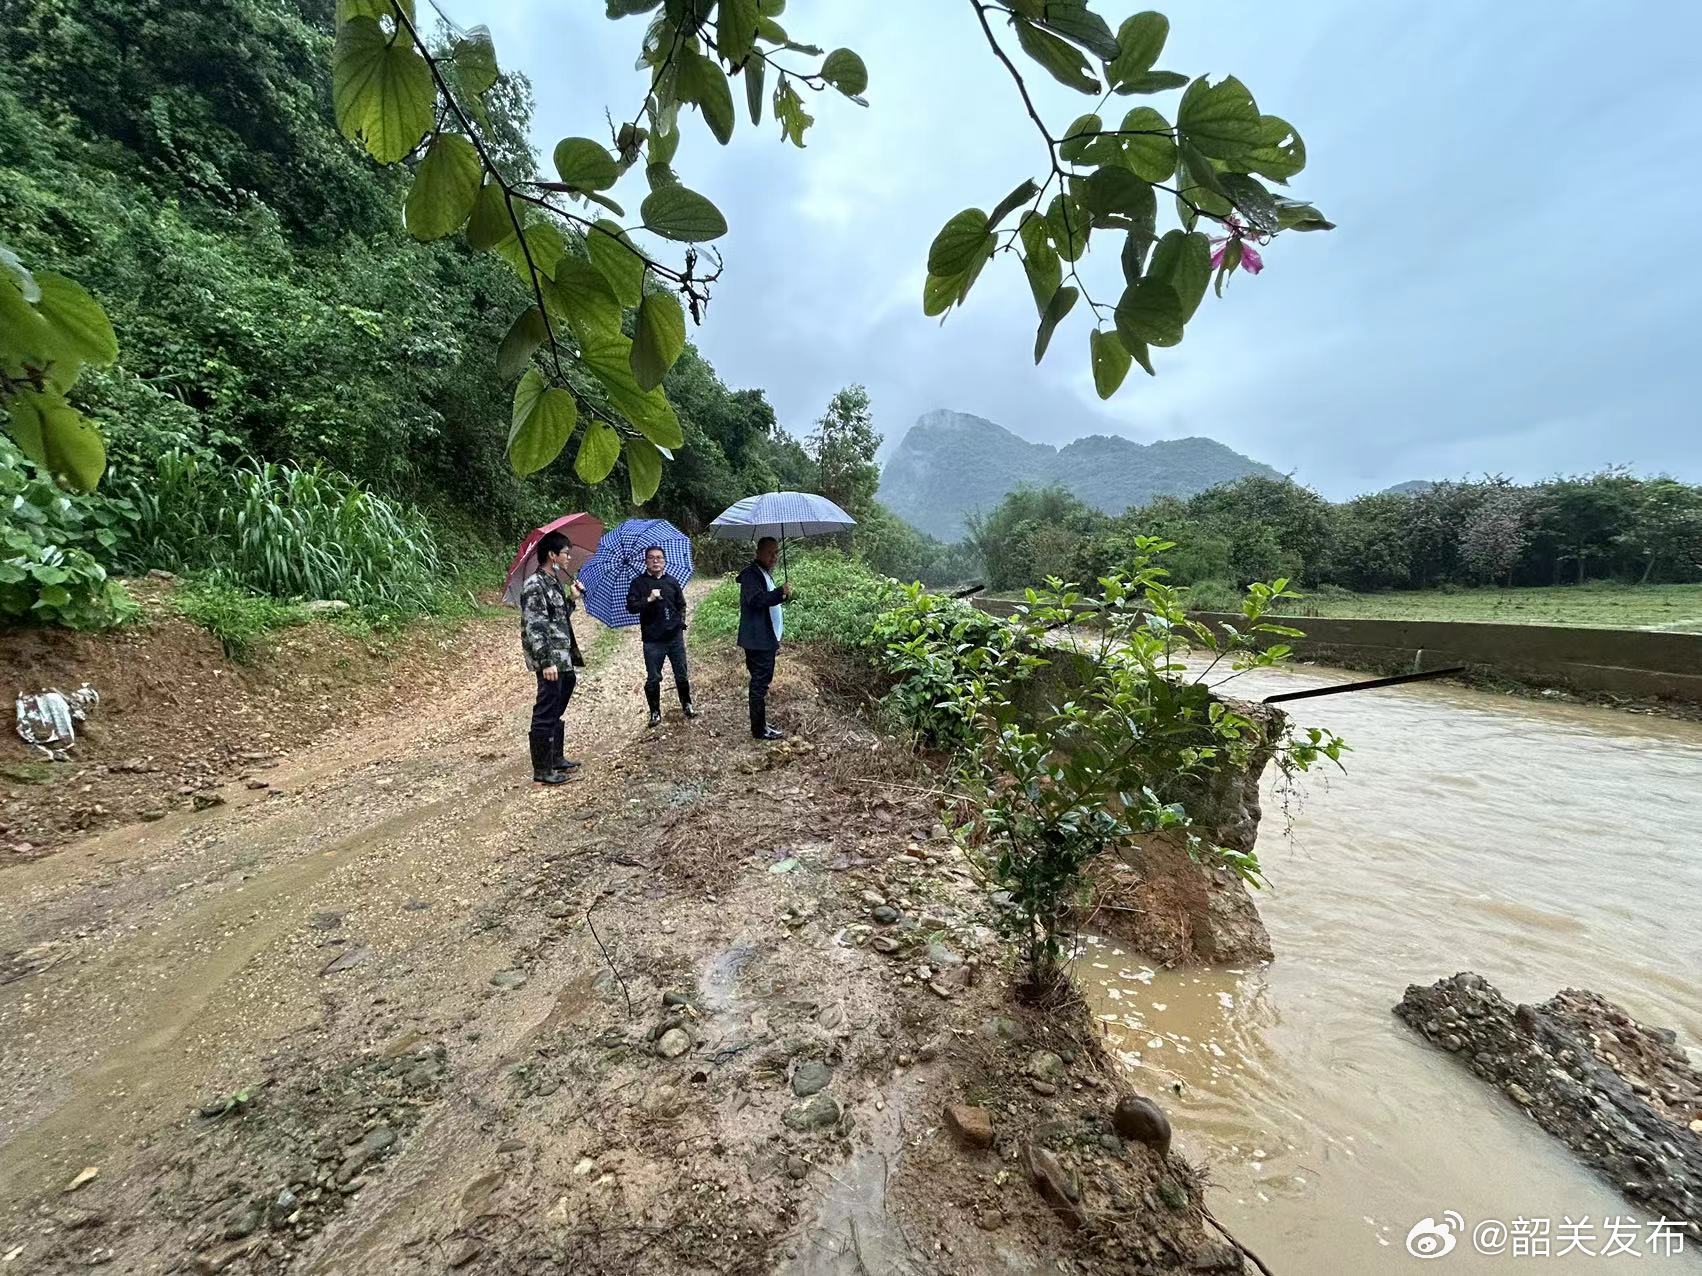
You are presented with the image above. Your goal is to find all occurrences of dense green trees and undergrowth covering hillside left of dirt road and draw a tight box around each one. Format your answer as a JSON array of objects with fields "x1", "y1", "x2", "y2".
[{"x1": 0, "y1": 0, "x2": 807, "y2": 626}]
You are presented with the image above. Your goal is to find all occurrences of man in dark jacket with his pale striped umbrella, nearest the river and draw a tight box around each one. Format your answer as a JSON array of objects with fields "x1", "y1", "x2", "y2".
[{"x1": 710, "y1": 492, "x2": 856, "y2": 740}]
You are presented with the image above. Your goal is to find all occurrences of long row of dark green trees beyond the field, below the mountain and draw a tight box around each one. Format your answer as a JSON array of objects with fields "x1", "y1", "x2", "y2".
[{"x1": 968, "y1": 470, "x2": 1702, "y2": 614}]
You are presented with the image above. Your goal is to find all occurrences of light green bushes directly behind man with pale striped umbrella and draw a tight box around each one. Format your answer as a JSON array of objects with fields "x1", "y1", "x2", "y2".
[{"x1": 691, "y1": 550, "x2": 902, "y2": 650}]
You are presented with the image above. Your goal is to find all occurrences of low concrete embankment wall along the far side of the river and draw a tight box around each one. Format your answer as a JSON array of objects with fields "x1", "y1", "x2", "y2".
[{"x1": 975, "y1": 601, "x2": 1702, "y2": 704}]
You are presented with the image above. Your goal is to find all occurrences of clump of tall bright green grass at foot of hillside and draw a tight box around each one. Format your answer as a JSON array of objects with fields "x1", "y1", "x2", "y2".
[{"x1": 123, "y1": 451, "x2": 446, "y2": 612}]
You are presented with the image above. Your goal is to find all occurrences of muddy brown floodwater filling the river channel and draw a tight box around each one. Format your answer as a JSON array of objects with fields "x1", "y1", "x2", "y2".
[{"x1": 1077, "y1": 669, "x2": 1702, "y2": 1276}]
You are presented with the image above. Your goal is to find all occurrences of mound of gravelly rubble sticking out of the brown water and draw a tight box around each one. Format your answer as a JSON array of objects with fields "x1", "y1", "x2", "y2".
[{"x1": 1394, "y1": 973, "x2": 1702, "y2": 1235}]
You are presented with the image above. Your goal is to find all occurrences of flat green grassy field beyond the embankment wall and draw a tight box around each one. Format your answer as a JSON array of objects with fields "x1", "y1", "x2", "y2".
[{"x1": 1288, "y1": 584, "x2": 1702, "y2": 633}]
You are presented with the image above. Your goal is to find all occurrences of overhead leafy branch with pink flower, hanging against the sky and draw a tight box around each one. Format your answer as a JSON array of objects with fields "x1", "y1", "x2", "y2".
[{"x1": 922, "y1": 0, "x2": 1333, "y2": 398}]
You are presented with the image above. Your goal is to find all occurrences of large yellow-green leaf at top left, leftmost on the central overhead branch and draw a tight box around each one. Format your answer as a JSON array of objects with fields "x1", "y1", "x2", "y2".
[{"x1": 332, "y1": 17, "x2": 428, "y2": 163}]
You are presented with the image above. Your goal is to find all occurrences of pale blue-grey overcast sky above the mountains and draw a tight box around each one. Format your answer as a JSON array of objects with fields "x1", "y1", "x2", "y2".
[{"x1": 443, "y1": 0, "x2": 1702, "y2": 498}]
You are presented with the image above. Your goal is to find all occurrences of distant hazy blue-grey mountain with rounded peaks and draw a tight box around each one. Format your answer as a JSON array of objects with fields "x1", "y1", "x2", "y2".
[{"x1": 878, "y1": 408, "x2": 1280, "y2": 541}]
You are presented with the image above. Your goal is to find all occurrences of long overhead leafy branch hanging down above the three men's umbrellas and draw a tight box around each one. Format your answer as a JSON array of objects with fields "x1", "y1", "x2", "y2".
[{"x1": 334, "y1": 0, "x2": 868, "y2": 504}]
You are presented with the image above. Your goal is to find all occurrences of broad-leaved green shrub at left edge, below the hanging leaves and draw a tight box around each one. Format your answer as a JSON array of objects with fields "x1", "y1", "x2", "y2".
[{"x1": 0, "y1": 436, "x2": 136, "y2": 629}]
